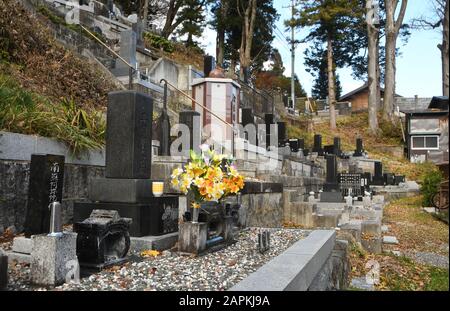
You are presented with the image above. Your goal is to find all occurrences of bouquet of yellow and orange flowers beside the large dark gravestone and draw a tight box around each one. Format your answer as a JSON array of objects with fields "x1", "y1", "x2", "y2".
[{"x1": 171, "y1": 145, "x2": 244, "y2": 222}]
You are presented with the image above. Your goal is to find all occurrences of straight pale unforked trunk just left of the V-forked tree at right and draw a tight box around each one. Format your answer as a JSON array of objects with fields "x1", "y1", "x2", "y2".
[{"x1": 366, "y1": 0, "x2": 378, "y2": 134}]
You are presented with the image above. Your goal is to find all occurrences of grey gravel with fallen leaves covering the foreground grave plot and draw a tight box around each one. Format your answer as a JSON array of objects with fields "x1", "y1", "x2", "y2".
[{"x1": 8, "y1": 228, "x2": 309, "y2": 291}]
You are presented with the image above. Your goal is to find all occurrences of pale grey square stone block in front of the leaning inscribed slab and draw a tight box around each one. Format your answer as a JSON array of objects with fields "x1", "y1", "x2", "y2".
[{"x1": 31, "y1": 232, "x2": 79, "y2": 286}]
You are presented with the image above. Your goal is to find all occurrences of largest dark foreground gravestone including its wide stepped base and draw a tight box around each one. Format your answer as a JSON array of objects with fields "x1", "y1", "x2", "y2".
[{"x1": 73, "y1": 91, "x2": 178, "y2": 237}]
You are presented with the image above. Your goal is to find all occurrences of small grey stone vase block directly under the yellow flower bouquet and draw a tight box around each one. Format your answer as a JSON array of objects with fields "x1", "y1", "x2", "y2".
[{"x1": 178, "y1": 221, "x2": 208, "y2": 254}]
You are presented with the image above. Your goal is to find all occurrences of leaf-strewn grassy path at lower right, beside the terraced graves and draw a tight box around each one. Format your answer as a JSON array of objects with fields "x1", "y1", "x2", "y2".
[{"x1": 350, "y1": 196, "x2": 449, "y2": 290}]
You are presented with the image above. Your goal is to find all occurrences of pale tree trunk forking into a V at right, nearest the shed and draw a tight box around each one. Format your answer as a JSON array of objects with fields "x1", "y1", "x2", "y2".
[{"x1": 383, "y1": 0, "x2": 408, "y2": 121}]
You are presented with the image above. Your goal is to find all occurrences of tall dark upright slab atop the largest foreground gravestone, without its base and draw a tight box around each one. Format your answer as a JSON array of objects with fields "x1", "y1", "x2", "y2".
[{"x1": 106, "y1": 91, "x2": 153, "y2": 178}]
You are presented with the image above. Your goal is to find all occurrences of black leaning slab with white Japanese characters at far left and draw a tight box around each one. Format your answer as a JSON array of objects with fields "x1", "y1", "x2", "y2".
[{"x1": 25, "y1": 154, "x2": 64, "y2": 237}]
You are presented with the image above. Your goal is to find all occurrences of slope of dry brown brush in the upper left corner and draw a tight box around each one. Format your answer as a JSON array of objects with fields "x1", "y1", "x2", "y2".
[{"x1": 0, "y1": 0, "x2": 115, "y2": 108}]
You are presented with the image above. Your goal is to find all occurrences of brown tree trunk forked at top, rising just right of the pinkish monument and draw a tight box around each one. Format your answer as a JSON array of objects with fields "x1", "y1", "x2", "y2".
[{"x1": 237, "y1": 0, "x2": 257, "y2": 80}]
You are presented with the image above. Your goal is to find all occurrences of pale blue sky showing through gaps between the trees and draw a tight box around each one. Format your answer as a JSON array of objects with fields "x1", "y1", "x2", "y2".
[{"x1": 201, "y1": 0, "x2": 442, "y2": 97}]
